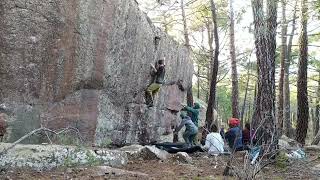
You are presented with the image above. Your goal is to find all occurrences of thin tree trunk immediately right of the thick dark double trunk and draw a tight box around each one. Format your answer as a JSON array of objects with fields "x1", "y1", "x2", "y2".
[{"x1": 277, "y1": 0, "x2": 288, "y2": 134}]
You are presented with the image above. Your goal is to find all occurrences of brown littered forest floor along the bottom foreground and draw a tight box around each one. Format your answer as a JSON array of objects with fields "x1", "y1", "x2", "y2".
[{"x1": 0, "y1": 152, "x2": 320, "y2": 180}]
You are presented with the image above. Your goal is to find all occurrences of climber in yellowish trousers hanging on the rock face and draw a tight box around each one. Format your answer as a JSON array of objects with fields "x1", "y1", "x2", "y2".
[{"x1": 146, "y1": 59, "x2": 166, "y2": 107}]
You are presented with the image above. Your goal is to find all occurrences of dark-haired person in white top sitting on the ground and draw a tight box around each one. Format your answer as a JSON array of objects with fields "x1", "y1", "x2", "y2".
[{"x1": 203, "y1": 125, "x2": 224, "y2": 155}]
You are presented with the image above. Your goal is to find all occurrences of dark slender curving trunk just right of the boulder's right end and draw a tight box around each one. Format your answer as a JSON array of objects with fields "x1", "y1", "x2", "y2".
[{"x1": 202, "y1": 0, "x2": 219, "y2": 140}]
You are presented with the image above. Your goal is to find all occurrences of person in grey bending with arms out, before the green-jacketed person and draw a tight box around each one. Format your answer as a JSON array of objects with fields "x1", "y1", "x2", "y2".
[{"x1": 174, "y1": 112, "x2": 198, "y2": 147}]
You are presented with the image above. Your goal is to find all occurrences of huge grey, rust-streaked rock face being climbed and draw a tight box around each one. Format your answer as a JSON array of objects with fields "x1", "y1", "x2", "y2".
[{"x1": 0, "y1": 0, "x2": 193, "y2": 145}]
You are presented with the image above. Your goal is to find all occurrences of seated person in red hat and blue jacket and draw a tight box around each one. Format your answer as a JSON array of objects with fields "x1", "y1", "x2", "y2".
[{"x1": 225, "y1": 118, "x2": 243, "y2": 151}]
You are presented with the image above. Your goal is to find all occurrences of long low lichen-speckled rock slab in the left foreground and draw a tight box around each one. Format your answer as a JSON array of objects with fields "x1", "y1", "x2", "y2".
[{"x1": 0, "y1": 143, "x2": 128, "y2": 170}]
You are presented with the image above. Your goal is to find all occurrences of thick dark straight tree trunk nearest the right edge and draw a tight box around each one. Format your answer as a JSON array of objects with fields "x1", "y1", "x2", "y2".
[{"x1": 296, "y1": 0, "x2": 309, "y2": 145}]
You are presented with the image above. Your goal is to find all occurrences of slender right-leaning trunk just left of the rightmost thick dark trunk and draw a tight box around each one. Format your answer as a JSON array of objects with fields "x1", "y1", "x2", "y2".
[{"x1": 283, "y1": 0, "x2": 298, "y2": 138}]
